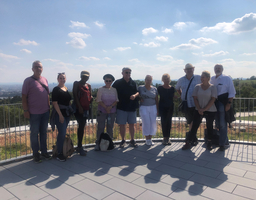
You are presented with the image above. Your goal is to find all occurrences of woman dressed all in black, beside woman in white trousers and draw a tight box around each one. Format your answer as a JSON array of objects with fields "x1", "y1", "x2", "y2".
[{"x1": 157, "y1": 74, "x2": 175, "y2": 145}]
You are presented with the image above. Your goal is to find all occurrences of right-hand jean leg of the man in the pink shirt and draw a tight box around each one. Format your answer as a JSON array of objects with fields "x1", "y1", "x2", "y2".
[{"x1": 39, "y1": 112, "x2": 49, "y2": 154}]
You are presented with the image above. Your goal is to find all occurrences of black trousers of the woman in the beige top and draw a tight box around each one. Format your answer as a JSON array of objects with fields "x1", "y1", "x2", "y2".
[{"x1": 188, "y1": 110, "x2": 216, "y2": 141}]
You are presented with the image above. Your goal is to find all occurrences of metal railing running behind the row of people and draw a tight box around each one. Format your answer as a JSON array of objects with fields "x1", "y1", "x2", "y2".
[{"x1": 0, "y1": 98, "x2": 256, "y2": 162}]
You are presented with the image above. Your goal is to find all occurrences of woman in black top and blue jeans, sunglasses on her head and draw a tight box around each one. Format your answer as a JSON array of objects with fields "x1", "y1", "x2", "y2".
[{"x1": 52, "y1": 73, "x2": 71, "y2": 161}]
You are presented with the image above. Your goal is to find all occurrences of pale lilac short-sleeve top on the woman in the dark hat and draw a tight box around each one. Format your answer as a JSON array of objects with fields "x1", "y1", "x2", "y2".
[{"x1": 96, "y1": 87, "x2": 118, "y2": 113}]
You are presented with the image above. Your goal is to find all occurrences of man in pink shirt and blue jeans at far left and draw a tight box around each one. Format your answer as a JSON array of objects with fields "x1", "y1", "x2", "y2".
[{"x1": 22, "y1": 60, "x2": 51, "y2": 163}]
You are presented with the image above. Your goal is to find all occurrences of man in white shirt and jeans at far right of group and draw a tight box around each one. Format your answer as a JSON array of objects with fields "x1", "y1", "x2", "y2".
[{"x1": 210, "y1": 64, "x2": 236, "y2": 151}]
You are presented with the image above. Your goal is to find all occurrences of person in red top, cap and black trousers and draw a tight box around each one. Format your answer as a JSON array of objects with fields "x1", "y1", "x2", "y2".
[{"x1": 73, "y1": 70, "x2": 93, "y2": 156}]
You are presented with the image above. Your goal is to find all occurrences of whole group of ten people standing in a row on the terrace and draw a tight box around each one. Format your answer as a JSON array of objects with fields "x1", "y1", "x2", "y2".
[{"x1": 22, "y1": 61, "x2": 235, "y2": 162}]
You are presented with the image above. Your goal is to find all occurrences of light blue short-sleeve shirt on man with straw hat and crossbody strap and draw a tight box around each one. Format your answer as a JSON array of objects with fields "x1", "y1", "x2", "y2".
[{"x1": 175, "y1": 75, "x2": 201, "y2": 108}]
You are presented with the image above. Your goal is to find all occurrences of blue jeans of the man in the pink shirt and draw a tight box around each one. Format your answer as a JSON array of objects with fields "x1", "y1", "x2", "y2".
[{"x1": 29, "y1": 111, "x2": 49, "y2": 155}]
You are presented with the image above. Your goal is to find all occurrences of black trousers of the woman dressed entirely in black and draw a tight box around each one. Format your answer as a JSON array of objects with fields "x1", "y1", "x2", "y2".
[{"x1": 159, "y1": 106, "x2": 173, "y2": 138}]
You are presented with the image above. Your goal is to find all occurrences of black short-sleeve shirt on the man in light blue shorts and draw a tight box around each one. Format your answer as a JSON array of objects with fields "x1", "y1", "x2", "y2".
[{"x1": 112, "y1": 78, "x2": 139, "y2": 112}]
